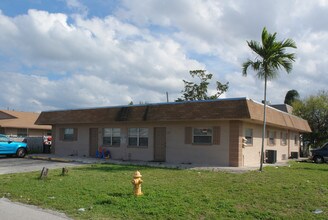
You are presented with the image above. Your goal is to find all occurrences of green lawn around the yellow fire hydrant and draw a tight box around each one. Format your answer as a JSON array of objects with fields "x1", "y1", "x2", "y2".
[{"x1": 0, "y1": 162, "x2": 328, "y2": 219}]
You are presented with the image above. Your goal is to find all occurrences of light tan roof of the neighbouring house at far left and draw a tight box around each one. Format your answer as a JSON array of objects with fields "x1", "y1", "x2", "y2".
[{"x1": 0, "y1": 110, "x2": 51, "y2": 130}]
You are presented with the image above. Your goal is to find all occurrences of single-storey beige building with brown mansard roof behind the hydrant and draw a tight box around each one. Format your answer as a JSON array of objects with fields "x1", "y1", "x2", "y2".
[{"x1": 36, "y1": 98, "x2": 311, "y2": 167}]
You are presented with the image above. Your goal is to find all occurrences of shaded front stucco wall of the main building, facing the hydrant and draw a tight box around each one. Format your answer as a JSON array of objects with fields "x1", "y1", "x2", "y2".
[{"x1": 55, "y1": 122, "x2": 229, "y2": 166}]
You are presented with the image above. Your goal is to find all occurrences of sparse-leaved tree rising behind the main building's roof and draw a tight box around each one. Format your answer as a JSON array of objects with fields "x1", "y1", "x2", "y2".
[{"x1": 175, "y1": 70, "x2": 229, "y2": 102}]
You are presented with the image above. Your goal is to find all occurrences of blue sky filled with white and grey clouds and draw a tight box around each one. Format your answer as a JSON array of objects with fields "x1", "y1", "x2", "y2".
[{"x1": 0, "y1": 0, "x2": 328, "y2": 112}]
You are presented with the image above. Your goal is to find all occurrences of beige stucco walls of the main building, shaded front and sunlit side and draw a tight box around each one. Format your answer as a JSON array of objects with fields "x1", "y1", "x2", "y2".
[{"x1": 53, "y1": 121, "x2": 298, "y2": 166}]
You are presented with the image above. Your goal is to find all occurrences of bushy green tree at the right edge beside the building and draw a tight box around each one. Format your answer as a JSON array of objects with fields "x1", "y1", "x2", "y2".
[{"x1": 293, "y1": 91, "x2": 328, "y2": 147}]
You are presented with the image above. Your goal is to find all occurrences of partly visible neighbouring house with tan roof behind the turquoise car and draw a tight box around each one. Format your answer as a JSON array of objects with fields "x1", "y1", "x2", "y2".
[{"x1": 0, "y1": 110, "x2": 51, "y2": 137}]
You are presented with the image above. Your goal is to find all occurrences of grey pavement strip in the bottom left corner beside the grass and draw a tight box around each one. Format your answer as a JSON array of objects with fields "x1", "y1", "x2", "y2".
[{"x1": 0, "y1": 198, "x2": 70, "y2": 220}]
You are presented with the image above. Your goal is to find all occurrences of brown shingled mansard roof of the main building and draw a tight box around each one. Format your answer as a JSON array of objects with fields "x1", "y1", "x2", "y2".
[{"x1": 36, "y1": 98, "x2": 311, "y2": 132}]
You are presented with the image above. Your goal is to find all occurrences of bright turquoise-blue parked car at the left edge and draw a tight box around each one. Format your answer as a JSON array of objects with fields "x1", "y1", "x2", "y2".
[{"x1": 0, "y1": 134, "x2": 28, "y2": 157}]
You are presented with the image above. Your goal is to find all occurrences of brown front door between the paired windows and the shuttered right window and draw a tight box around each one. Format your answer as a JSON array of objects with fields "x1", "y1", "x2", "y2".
[{"x1": 154, "y1": 127, "x2": 166, "y2": 161}]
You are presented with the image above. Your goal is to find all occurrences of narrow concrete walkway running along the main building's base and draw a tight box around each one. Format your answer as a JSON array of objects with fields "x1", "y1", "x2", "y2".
[{"x1": 27, "y1": 154, "x2": 288, "y2": 173}]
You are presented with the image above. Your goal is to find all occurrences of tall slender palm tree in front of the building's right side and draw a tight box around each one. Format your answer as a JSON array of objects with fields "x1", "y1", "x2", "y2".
[{"x1": 242, "y1": 27, "x2": 296, "y2": 171}]
